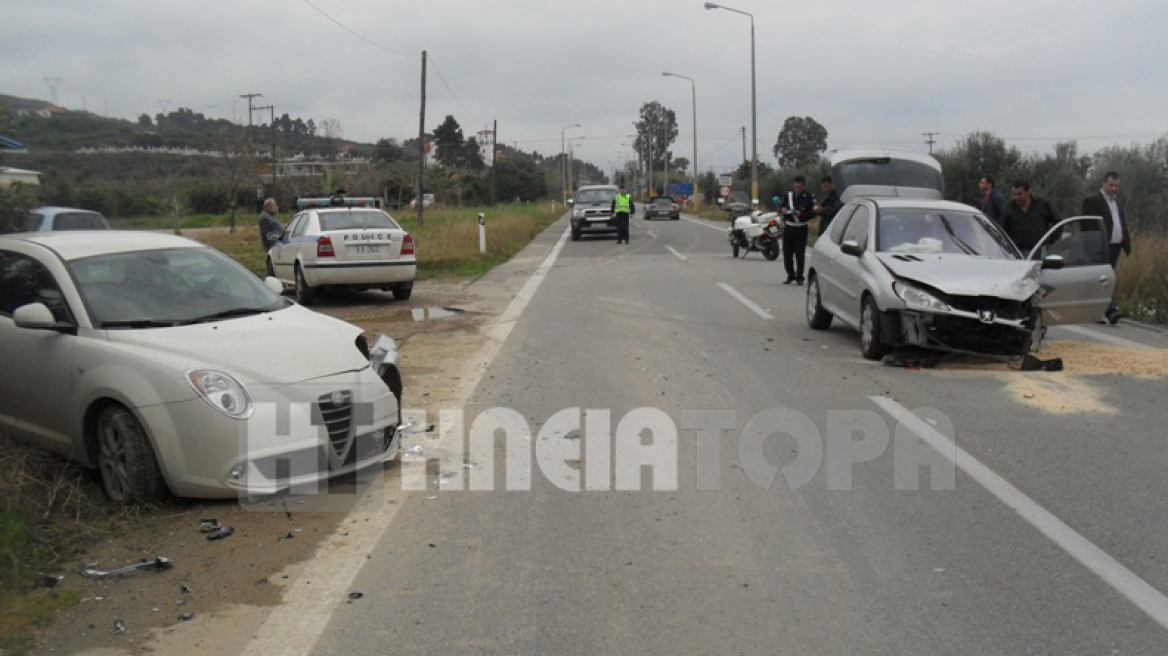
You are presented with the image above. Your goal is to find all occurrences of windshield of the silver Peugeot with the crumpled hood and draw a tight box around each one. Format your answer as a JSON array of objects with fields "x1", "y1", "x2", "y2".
[{"x1": 876, "y1": 208, "x2": 1021, "y2": 259}]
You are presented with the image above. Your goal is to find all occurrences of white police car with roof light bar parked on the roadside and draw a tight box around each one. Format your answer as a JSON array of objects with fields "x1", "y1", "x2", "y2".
[{"x1": 267, "y1": 197, "x2": 417, "y2": 305}]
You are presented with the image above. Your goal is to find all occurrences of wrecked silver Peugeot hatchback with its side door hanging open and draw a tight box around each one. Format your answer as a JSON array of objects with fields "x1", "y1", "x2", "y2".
[{"x1": 807, "y1": 197, "x2": 1115, "y2": 360}]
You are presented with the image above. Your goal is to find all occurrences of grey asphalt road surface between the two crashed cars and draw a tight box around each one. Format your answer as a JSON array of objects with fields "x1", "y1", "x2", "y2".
[{"x1": 303, "y1": 212, "x2": 1168, "y2": 656}]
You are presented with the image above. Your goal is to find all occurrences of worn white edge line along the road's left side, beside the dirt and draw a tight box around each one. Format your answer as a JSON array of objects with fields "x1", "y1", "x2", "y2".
[{"x1": 243, "y1": 229, "x2": 571, "y2": 656}]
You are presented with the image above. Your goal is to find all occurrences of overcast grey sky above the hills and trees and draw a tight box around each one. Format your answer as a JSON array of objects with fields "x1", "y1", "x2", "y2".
[{"x1": 0, "y1": 0, "x2": 1168, "y2": 170}]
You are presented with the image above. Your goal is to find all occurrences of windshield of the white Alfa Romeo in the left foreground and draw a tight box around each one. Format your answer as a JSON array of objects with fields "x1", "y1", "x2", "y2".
[{"x1": 68, "y1": 249, "x2": 288, "y2": 328}]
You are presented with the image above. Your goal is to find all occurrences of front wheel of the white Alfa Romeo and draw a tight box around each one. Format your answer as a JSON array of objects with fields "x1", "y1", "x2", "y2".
[{"x1": 96, "y1": 405, "x2": 167, "y2": 505}]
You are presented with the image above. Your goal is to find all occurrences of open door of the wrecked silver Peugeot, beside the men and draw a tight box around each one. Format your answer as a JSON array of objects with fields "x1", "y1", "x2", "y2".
[{"x1": 1030, "y1": 216, "x2": 1115, "y2": 326}]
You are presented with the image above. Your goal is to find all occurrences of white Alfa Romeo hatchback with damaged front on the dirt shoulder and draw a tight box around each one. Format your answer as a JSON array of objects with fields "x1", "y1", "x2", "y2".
[{"x1": 0, "y1": 230, "x2": 402, "y2": 503}]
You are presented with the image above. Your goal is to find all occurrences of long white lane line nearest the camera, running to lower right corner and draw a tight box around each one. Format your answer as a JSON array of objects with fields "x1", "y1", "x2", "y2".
[{"x1": 868, "y1": 396, "x2": 1168, "y2": 629}]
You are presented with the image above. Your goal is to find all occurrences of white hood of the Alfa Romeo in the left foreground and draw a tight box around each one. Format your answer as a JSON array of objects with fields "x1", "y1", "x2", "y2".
[{"x1": 106, "y1": 306, "x2": 369, "y2": 386}]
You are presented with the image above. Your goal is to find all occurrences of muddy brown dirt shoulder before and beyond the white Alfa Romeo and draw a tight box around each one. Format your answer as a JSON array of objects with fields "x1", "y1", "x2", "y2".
[{"x1": 23, "y1": 267, "x2": 520, "y2": 654}]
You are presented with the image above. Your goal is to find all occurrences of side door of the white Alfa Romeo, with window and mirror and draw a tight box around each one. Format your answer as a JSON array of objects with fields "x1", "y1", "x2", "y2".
[{"x1": 0, "y1": 251, "x2": 77, "y2": 451}]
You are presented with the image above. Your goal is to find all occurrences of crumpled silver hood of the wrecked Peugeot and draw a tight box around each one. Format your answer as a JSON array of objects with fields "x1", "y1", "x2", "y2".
[{"x1": 876, "y1": 253, "x2": 1042, "y2": 301}]
